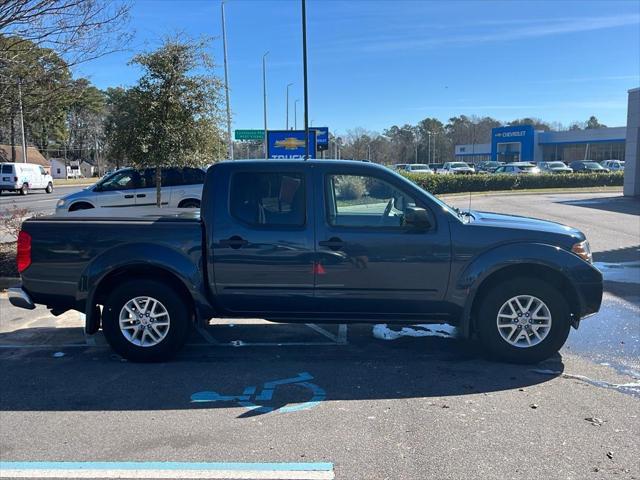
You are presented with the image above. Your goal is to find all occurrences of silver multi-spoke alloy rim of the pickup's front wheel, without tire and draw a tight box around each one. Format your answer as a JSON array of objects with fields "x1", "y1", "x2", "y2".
[{"x1": 497, "y1": 295, "x2": 551, "y2": 348}]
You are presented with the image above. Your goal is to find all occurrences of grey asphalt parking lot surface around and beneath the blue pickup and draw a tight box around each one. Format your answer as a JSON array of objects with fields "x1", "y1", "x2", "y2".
[{"x1": 0, "y1": 189, "x2": 640, "y2": 479}]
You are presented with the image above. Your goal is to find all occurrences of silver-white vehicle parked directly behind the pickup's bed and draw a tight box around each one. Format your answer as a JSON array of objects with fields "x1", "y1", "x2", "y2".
[{"x1": 56, "y1": 167, "x2": 205, "y2": 214}]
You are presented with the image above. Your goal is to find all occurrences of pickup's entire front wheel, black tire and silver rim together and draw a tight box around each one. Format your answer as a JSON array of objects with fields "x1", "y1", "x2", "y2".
[{"x1": 477, "y1": 277, "x2": 571, "y2": 363}]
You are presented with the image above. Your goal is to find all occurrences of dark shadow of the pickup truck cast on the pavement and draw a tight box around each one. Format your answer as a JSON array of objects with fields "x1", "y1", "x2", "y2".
[{"x1": 0, "y1": 325, "x2": 564, "y2": 418}]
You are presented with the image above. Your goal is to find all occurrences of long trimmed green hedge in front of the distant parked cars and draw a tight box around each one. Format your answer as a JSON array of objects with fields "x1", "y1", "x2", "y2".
[{"x1": 403, "y1": 172, "x2": 624, "y2": 195}]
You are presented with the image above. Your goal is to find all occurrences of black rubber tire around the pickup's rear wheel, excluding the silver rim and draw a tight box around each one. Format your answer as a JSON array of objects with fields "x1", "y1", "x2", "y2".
[{"x1": 102, "y1": 279, "x2": 191, "y2": 362}]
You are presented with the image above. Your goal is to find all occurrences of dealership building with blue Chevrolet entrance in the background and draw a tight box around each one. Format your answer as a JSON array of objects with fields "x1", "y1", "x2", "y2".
[{"x1": 455, "y1": 125, "x2": 627, "y2": 163}]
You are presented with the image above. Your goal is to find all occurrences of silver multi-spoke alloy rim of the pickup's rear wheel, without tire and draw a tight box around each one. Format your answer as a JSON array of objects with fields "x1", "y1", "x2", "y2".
[{"x1": 119, "y1": 297, "x2": 171, "y2": 347}]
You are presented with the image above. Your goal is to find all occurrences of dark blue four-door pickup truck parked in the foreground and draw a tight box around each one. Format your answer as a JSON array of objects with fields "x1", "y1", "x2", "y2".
[{"x1": 10, "y1": 160, "x2": 602, "y2": 362}]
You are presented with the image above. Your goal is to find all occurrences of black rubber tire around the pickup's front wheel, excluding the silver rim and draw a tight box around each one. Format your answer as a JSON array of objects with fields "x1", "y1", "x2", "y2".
[{"x1": 477, "y1": 277, "x2": 571, "y2": 363}]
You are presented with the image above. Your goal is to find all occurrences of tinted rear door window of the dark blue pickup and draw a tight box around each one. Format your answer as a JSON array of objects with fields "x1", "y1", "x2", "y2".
[{"x1": 230, "y1": 172, "x2": 306, "y2": 227}]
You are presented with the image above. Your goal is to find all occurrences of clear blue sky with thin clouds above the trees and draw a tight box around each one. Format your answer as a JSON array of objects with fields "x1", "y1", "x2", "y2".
[{"x1": 77, "y1": 0, "x2": 640, "y2": 133}]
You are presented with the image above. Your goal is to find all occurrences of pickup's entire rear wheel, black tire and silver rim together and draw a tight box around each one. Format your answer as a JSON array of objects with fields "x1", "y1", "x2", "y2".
[{"x1": 102, "y1": 280, "x2": 191, "y2": 362}]
